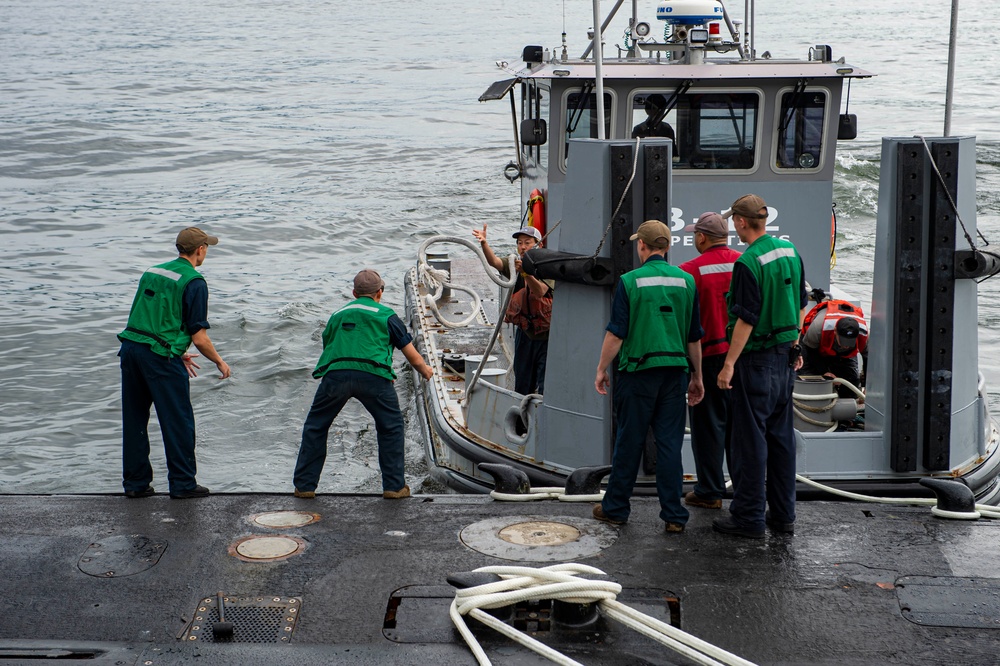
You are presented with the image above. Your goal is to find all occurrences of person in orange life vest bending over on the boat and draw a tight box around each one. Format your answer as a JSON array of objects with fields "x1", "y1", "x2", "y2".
[{"x1": 799, "y1": 300, "x2": 868, "y2": 398}]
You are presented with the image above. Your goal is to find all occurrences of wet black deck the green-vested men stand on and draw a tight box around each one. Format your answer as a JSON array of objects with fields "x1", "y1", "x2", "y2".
[{"x1": 0, "y1": 495, "x2": 1000, "y2": 665}]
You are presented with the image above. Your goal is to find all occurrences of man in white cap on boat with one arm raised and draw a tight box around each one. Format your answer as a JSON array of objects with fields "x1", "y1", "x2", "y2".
[{"x1": 472, "y1": 224, "x2": 555, "y2": 395}]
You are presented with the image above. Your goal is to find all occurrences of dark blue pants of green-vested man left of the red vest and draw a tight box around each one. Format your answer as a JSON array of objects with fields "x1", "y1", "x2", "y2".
[{"x1": 602, "y1": 367, "x2": 689, "y2": 525}]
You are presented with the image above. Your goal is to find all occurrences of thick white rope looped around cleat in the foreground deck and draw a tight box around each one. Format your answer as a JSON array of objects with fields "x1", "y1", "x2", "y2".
[{"x1": 450, "y1": 562, "x2": 754, "y2": 666}]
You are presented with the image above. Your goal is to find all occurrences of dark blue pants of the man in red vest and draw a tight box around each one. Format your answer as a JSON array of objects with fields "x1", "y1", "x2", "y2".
[{"x1": 690, "y1": 354, "x2": 732, "y2": 500}]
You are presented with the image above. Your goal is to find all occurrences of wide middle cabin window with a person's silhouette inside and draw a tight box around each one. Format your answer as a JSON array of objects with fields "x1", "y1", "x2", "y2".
[{"x1": 631, "y1": 89, "x2": 760, "y2": 170}]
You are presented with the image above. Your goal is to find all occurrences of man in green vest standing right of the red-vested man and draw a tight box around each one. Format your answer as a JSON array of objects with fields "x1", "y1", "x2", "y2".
[{"x1": 712, "y1": 194, "x2": 809, "y2": 539}]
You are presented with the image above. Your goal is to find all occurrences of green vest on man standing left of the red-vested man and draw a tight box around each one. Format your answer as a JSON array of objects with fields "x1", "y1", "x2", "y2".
[{"x1": 618, "y1": 260, "x2": 695, "y2": 372}]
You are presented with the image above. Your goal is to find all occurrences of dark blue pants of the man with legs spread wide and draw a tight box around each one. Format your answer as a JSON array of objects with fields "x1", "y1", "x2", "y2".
[{"x1": 294, "y1": 370, "x2": 406, "y2": 491}]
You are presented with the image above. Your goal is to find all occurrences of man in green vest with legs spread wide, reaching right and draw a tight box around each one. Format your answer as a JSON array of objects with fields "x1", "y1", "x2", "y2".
[{"x1": 293, "y1": 269, "x2": 434, "y2": 499}]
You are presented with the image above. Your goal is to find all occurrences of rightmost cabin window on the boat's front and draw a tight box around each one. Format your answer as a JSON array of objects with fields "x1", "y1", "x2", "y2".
[{"x1": 777, "y1": 89, "x2": 827, "y2": 169}]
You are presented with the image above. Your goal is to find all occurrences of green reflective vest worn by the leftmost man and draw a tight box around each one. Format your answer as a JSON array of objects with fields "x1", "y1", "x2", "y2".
[{"x1": 118, "y1": 257, "x2": 204, "y2": 358}]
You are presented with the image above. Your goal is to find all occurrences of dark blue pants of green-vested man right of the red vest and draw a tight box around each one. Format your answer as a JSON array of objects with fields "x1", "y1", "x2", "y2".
[{"x1": 729, "y1": 345, "x2": 795, "y2": 530}]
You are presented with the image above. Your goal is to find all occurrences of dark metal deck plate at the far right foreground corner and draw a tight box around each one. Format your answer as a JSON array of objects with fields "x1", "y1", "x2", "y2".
[{"x1": 896, "y1": 576, "x2": 1000, "y2": 629}]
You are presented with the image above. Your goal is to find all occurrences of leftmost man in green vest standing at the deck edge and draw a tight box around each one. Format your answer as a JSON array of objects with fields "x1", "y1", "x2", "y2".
[{"x1": 118, "y1": 227, "x2": 230, "y2": 499}]
